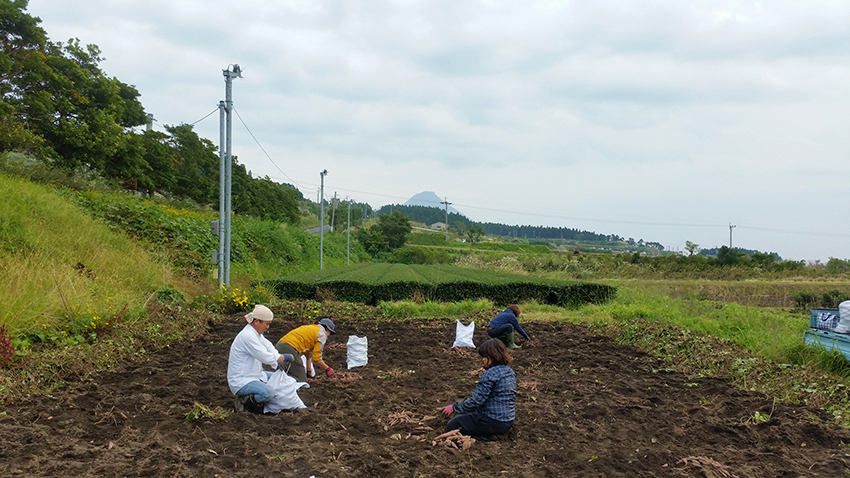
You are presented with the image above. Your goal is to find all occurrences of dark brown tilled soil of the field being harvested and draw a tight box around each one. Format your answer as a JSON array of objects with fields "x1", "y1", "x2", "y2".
[{"x1": 0, "y1": 316, "x2": 850, "y2": 478}]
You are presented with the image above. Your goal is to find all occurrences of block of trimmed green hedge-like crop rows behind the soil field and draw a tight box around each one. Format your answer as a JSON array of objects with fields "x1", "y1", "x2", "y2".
[{"x1": 260, "y1": 263, "x2": 616, "y2": 307}]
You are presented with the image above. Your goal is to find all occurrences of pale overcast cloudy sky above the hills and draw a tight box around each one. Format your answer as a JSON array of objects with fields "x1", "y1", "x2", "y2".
[{"x1": 27, "y1": 0, "x2": 850, "y2": 262}]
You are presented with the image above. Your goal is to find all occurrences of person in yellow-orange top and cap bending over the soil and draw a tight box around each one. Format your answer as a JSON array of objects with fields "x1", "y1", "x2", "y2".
[{"x1": 275, "y1": 318, "x2": 336, "y2": 382}]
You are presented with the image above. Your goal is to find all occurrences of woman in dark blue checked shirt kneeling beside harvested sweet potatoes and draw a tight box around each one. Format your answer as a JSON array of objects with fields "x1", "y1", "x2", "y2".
[{"x1": 443, "y1": 339, "x2": 516, "y2": 438}]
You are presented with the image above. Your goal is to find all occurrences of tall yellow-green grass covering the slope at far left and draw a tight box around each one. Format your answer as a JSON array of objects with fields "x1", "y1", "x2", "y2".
[{"x1": 0, "y1": 175, "x2": 173, "y2": 335}]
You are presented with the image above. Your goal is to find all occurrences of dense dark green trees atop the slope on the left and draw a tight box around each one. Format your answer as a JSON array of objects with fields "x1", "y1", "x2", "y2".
[{"x1": 0, "y1": 0, "x2": 302, "y2": 223}]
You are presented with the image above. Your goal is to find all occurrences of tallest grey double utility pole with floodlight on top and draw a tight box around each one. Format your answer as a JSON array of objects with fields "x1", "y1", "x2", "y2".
[{"x1": 217, "y1": 63, "x2": 242, "y2": 288}]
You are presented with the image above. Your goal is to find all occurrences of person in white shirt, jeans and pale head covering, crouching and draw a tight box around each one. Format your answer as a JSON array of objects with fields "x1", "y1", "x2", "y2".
[{"x1": 227, "y1": 304, "x2": 294, "y2": 414}]
